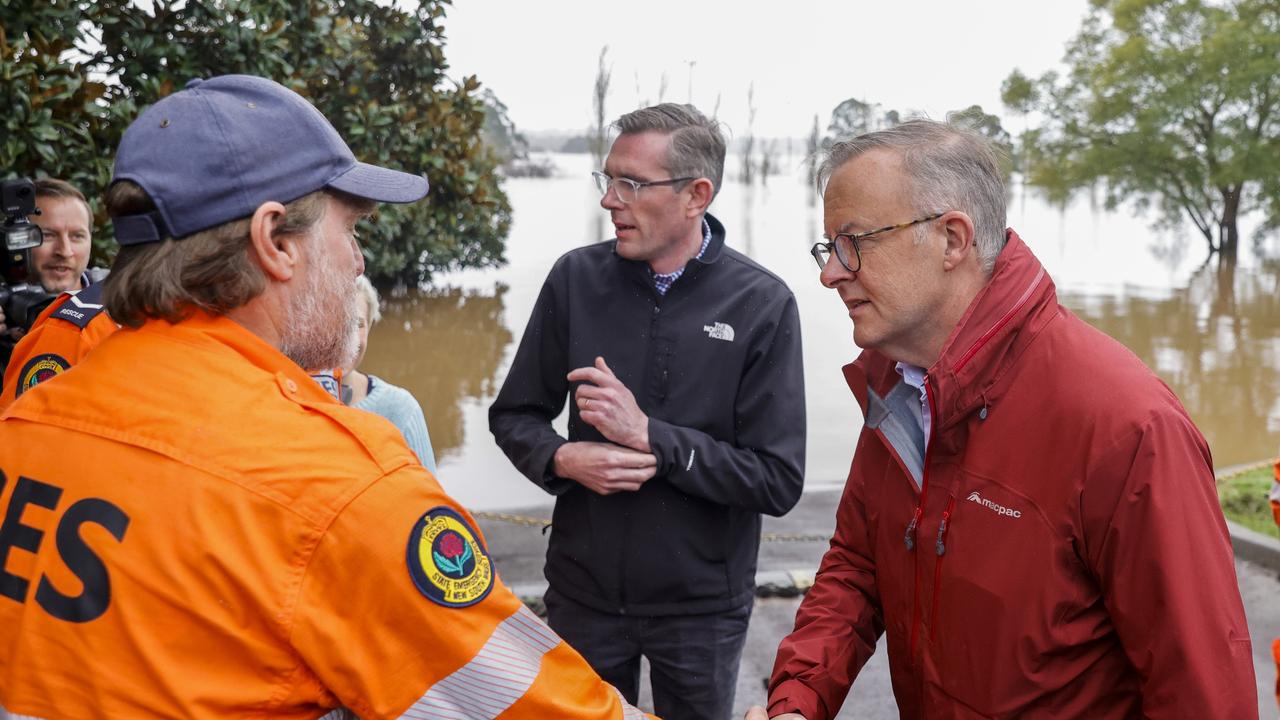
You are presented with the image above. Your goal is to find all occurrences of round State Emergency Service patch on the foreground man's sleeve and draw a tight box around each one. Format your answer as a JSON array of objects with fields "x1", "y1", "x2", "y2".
[{"x1": 406, "y1": 505, "x2": 493, "y2": 607}]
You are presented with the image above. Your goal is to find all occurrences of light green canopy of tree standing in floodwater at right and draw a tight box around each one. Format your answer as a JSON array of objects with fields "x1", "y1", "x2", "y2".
[{"x1": 1005, "y1": 0, "x2": 1280, "y2": 258}]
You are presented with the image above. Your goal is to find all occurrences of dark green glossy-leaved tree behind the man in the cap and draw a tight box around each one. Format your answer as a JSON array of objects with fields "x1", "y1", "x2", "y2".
[{"x1": 0, "y1": 0, "x2": 511, "y2": 283}]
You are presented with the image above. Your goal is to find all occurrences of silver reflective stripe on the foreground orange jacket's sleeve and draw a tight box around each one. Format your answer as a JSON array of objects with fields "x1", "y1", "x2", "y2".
[{"x1": 401, "y1": 605, "x2": 561, "y2": 720}]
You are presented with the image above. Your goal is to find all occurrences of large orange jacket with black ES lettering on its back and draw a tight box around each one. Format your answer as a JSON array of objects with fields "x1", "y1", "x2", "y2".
[{"x1": 0, "y1": 315, "x2": 644, "y2": 720}]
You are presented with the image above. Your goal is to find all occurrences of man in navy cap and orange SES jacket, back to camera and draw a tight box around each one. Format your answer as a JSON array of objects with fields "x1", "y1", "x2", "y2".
[{"x1": 0, "y1": 76, "x2": 643, "y2": 720}]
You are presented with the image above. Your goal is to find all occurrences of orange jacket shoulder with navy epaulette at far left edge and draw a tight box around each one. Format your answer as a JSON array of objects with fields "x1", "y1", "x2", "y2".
[{"x1": 0, "y1": 283, "x2": 116, "y2": 411}]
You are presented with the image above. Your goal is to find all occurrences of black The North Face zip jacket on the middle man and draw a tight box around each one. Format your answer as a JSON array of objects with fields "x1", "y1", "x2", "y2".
[{"x1": 489, "y1": 215, "x2": 805, "y2": 615}]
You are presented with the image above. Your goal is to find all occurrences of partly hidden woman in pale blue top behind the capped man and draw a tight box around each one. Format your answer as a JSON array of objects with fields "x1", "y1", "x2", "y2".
[{"x1": 342, "y1": 275, "x2": 436, "y2": 475}]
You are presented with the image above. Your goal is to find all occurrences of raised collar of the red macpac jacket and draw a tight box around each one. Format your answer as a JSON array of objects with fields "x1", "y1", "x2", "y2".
[{"x1": 844, "y1": 229, "x2": 1059, "y2": 432}]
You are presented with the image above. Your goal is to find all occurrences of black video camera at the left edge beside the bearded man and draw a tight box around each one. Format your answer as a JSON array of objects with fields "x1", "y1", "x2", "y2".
[{"x1": 0, "y1": 178, "x2": 56, "y2": 329}]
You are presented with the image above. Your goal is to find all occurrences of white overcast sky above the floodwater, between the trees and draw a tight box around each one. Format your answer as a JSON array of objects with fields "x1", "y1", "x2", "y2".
[{"x1": 444, "y1": 0, "x2": 1088, "y2": 137}]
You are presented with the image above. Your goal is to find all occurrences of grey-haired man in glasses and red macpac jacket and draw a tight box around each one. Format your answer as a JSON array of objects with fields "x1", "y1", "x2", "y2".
[{"x1": 748, "y1": 120, "x2": 1257, "y2": 720}]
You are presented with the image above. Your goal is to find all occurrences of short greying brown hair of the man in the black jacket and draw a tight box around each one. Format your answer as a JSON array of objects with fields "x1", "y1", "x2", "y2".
[{"x1": 613, "y1": 102, "x2": 724, "y2": 199}]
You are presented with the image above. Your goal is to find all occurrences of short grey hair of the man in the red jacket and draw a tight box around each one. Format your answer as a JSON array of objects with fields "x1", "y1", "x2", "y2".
[{"x1": 817, "y1": 119, "x2": 1006, "y2": 277}]
